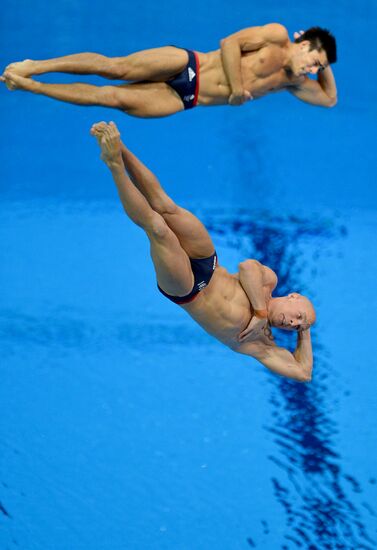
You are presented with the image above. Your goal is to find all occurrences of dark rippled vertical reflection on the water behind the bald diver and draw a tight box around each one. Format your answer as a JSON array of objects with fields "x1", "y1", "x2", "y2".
[{"x1": 205, "y1": 210, "x2": 377, "y2": 550}]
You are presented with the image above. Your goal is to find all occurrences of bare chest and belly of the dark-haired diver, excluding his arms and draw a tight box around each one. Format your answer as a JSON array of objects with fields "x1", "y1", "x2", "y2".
[{"x1": 198, "y1": 44, "x2": 303, "y2": 105}]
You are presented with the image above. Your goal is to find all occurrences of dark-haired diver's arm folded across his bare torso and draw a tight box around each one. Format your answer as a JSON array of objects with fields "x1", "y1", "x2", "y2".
[{"x1": 221, "y1": 23, "x2": 288, "y2": 105}]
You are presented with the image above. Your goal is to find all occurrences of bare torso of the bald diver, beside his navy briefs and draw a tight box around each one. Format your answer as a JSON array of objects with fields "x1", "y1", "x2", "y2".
[{"x1": 181, "y1": 266, "x2": 272, "y2": 351}]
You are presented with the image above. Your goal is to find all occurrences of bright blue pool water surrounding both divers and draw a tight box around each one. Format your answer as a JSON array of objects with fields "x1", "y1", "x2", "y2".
[{"x1": 0, "y1": 0, "x2": 377, "y2": 550}]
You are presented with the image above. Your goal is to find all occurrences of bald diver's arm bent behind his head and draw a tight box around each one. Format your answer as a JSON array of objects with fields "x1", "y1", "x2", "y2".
[{"x1": 237, "y1": 329, "x2": 313, "y2": 382}]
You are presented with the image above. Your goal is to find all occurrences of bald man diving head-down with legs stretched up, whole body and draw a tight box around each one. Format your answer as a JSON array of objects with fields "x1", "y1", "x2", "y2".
[{"x1": 91, "y1": 122, "x2": 315, "y2": 382}]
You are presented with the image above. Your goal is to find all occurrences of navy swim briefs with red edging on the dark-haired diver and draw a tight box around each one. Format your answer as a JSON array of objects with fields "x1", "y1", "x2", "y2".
[{"x1": 166, "y1": 46, "x2": 199, "y2": 109}]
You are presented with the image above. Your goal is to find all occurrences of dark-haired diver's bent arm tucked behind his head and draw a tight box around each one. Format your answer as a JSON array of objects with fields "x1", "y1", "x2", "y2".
[{"x1": 288, "y1": 66, "x2": 338, "y2": 107}]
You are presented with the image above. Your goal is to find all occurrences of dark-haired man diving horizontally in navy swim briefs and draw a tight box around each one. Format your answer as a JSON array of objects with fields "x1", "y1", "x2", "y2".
[{"x1": 0, "y1": 23, "x2": 337, "y2": 118}]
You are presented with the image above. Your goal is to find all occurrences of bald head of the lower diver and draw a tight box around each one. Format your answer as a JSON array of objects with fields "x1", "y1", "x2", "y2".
[{"x1": 268, "y1": 292, "x2": 314, "y2": 330}]
